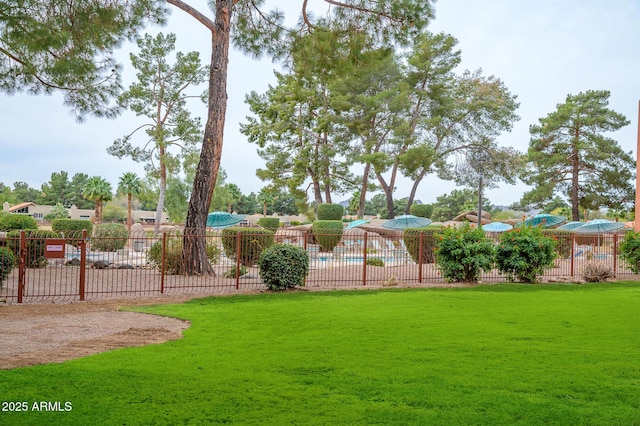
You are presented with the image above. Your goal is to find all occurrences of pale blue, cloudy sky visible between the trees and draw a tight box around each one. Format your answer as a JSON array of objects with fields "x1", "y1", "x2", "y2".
[{"x1": 0, "y1": 0, "x2": 640, "y2": 205}]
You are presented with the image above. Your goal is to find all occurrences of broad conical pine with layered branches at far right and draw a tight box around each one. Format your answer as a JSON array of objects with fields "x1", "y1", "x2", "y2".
[{"x1": 521, "y1": 90, "x2": 635, "y2": 220}]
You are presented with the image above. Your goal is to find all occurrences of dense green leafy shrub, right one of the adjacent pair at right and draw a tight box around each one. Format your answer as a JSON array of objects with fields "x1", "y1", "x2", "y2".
[{"x1": 496, "y1": 226, "x2": 556, "y2": 283}]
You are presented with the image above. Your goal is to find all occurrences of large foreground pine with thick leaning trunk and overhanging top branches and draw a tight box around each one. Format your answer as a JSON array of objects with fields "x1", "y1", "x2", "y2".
[{"x1": 167, "y1": 0, "x2": 433, "y2": 274}]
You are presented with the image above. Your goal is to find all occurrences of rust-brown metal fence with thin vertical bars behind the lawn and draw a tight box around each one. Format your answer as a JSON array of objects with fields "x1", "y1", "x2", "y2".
[{"x1": 0, "y1": 230, "x2": 633, "y2": 303}]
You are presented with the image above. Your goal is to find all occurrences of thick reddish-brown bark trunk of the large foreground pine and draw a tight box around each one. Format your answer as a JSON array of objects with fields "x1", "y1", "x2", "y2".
[{"x1": 180, "y1": 0, "x2": 234, "y2": 275}]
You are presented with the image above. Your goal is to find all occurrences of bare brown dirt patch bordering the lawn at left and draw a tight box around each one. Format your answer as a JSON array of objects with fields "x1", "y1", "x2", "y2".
[{"x1": 0, "y1": 296, "x2": 200, "y2": 369}]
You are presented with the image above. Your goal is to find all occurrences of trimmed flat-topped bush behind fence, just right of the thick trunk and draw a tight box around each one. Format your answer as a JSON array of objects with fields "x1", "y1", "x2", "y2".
[{"x1": 222, "y1": 227, "x2": 275, "y2": 266}]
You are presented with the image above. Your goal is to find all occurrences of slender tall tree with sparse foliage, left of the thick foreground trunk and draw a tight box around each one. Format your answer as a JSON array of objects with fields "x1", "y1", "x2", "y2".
[{"x1": 107, "y1": 33, "x2": 206, "y2": 232}]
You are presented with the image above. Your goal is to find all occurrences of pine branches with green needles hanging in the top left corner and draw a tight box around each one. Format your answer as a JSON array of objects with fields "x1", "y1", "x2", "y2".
[{"x1": 0, "y1": 0, "x2": 165, "y2": 118}]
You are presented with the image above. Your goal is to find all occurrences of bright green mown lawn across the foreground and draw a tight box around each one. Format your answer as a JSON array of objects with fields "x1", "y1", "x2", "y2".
[{"x1": 0, "y1": 283, "x2": 640, "y2": 425}]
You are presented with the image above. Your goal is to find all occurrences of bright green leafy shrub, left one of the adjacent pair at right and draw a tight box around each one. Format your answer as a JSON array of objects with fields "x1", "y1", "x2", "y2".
[{"x1": 436, "y1": 224, "x2": 494, "y2": 282}]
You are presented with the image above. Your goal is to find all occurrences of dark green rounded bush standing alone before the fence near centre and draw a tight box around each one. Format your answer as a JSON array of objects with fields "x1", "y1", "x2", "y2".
[{"x1": 258, "y1": 244, "x2": 309, "y2": 291}]
